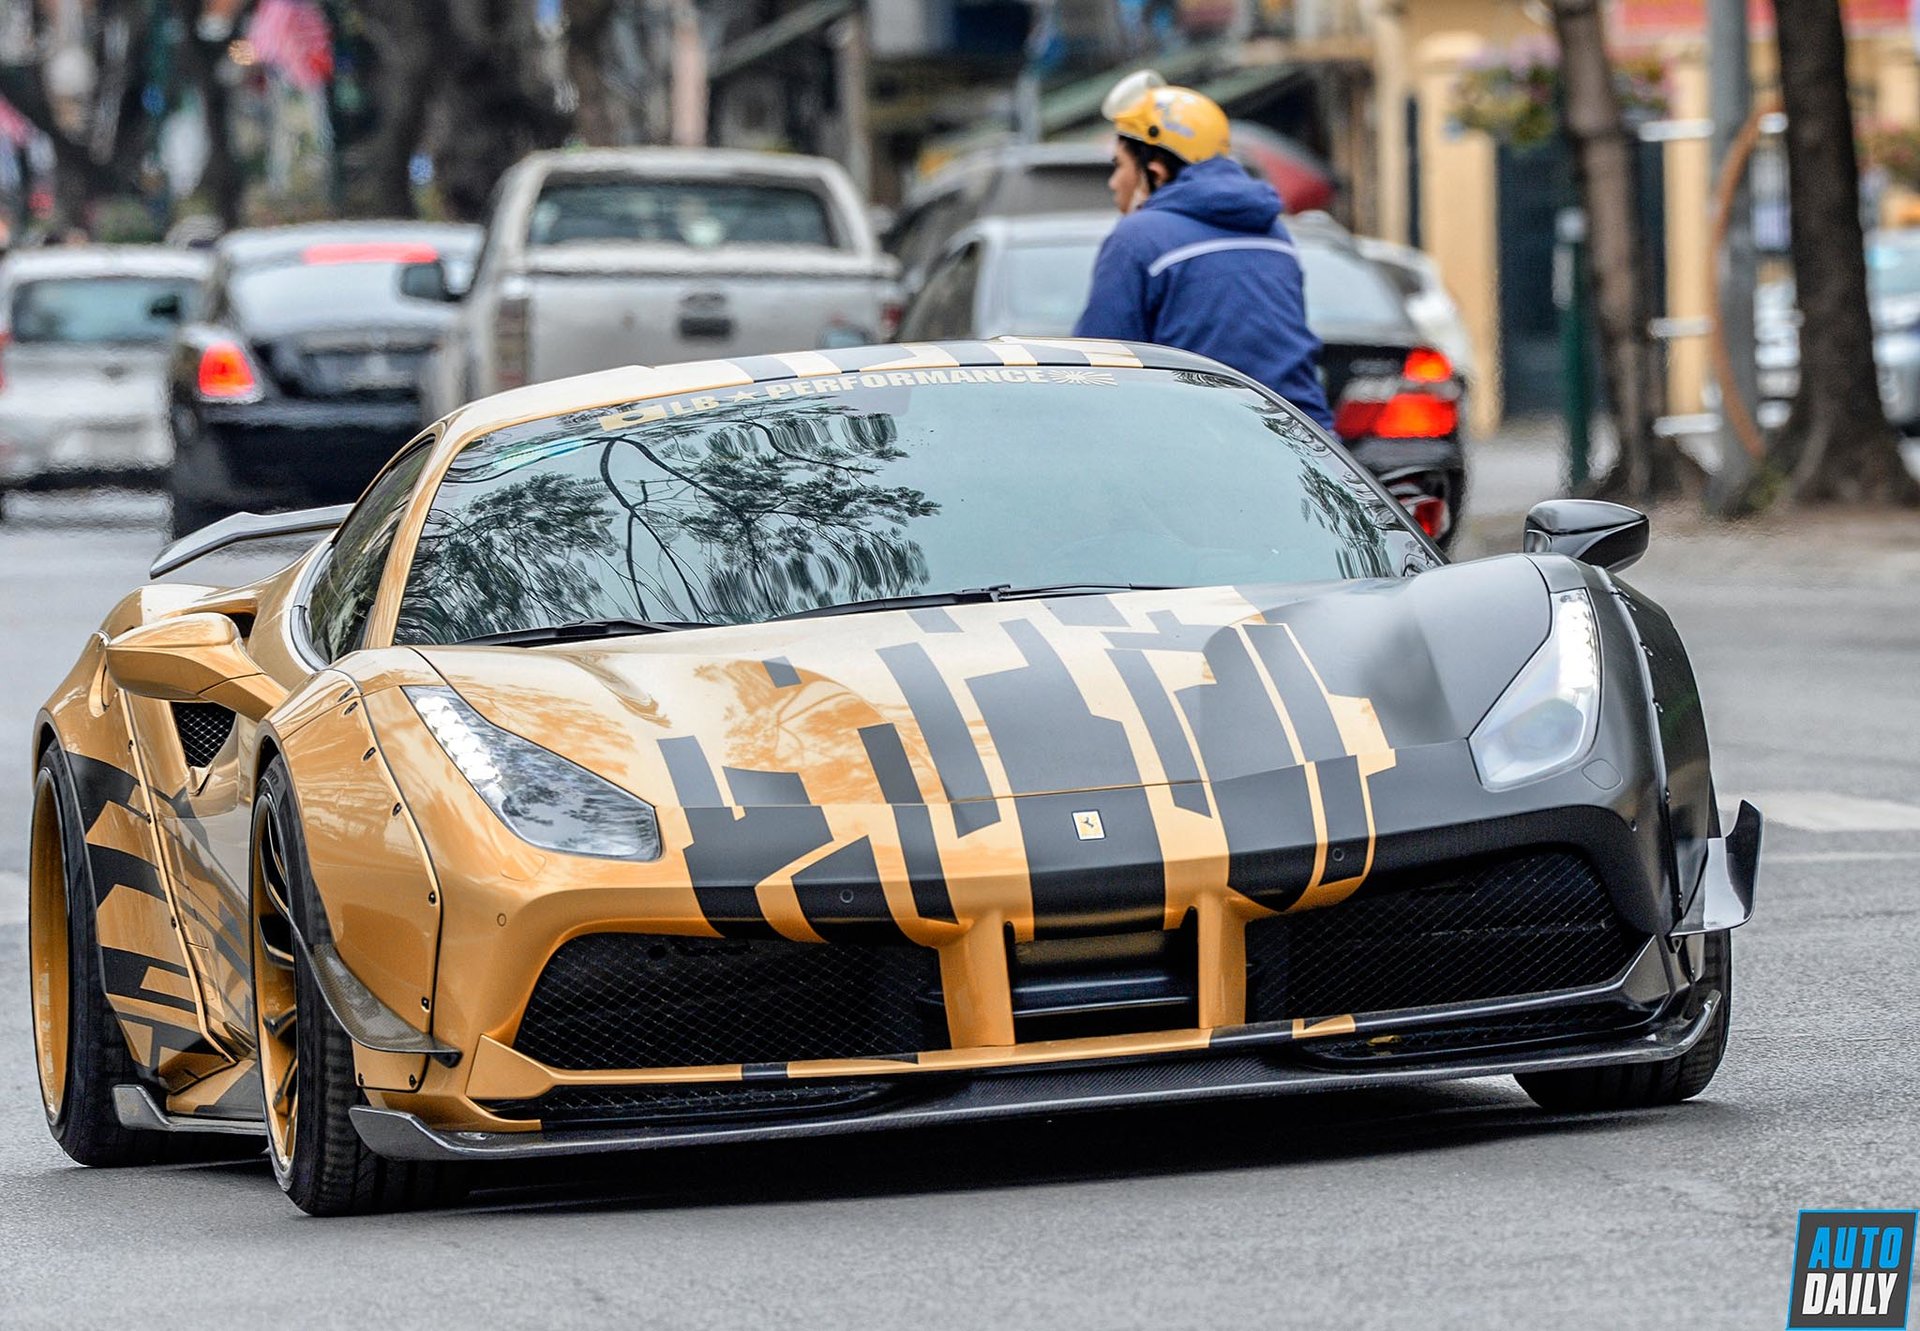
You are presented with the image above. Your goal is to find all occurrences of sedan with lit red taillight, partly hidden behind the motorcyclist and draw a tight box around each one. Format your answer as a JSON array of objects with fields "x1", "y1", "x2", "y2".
[{"x1": 900, "y1": 211, "x2": 1467, "y2": 545}]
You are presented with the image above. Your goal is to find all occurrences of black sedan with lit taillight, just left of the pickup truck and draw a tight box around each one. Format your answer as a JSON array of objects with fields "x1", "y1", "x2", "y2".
[{"x1": 167, "y1": 223, "x2": 480, "y2": 536}]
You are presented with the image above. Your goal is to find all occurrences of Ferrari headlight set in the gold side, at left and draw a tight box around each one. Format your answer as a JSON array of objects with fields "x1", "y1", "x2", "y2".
[{"x1": 405, "y1": 686, "x2": 660, "y2": 860}]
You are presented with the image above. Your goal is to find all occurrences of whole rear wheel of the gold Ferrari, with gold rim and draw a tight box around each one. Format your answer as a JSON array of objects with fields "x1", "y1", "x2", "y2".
[{"x1": 27, "y1": 743, "x2": 188, "y2": 1166}]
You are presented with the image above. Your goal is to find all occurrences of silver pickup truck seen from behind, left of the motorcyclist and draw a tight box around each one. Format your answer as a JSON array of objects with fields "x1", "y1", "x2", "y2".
[{"x1": 422, "y1": 148, "x2": 899, "y2": 415}]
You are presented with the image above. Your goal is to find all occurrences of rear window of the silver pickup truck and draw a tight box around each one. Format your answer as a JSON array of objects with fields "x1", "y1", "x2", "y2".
[{"x1": 526, "y1": 181, "x2": 833, "y2": 250}]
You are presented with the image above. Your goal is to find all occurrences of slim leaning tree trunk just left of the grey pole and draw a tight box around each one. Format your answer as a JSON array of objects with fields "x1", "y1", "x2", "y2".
[{"x1": 1553, "y1": 0, "x2": 1682, "y2": 503}]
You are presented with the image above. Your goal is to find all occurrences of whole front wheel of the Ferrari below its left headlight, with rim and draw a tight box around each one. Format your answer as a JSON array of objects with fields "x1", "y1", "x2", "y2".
[{"x1": 252, "y1": 759, "x2": 465, "y2": 1216}]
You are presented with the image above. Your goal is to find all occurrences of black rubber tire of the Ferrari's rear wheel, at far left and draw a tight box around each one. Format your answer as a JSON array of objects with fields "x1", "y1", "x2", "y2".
[{"x1": 27, "y1": 743, "x2": 198, "y2": 1168}]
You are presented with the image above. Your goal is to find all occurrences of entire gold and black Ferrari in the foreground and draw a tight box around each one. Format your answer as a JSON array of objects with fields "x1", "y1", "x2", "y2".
[{"x1": 29, "y1": 340, "x2": 1761, "y2": 1214}]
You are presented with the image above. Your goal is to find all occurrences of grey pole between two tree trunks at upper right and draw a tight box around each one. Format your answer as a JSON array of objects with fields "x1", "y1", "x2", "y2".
[{"x1": 1707, "y1": 0, "x2": 1759, "y2": 511}]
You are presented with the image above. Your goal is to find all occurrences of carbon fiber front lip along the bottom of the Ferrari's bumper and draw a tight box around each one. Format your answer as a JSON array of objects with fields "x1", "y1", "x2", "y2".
[{"x1": 351, "y1": 991, "x2": 1722, "y2": 1160}]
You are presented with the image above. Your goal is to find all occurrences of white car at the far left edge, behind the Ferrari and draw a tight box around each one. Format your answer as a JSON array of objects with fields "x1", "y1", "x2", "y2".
[{"x1": 0, "y1": 246, "x2": 209, "y2": 513}]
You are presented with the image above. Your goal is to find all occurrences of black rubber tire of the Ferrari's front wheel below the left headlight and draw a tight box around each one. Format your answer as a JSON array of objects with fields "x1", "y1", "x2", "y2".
[{"x1": 253, "y1": 759, "x2": 467, "y2": 1216}]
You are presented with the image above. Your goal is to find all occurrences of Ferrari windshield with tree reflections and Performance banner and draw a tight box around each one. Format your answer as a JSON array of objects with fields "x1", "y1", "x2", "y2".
[{"x1": 396, "y1": 367, "x2": 1432, "y2": 643}]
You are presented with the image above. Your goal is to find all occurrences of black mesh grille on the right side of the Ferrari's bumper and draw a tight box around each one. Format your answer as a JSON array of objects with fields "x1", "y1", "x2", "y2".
[{"x1": 1246, "y1": 851, "x2": 1644, "y2": 1022}]
